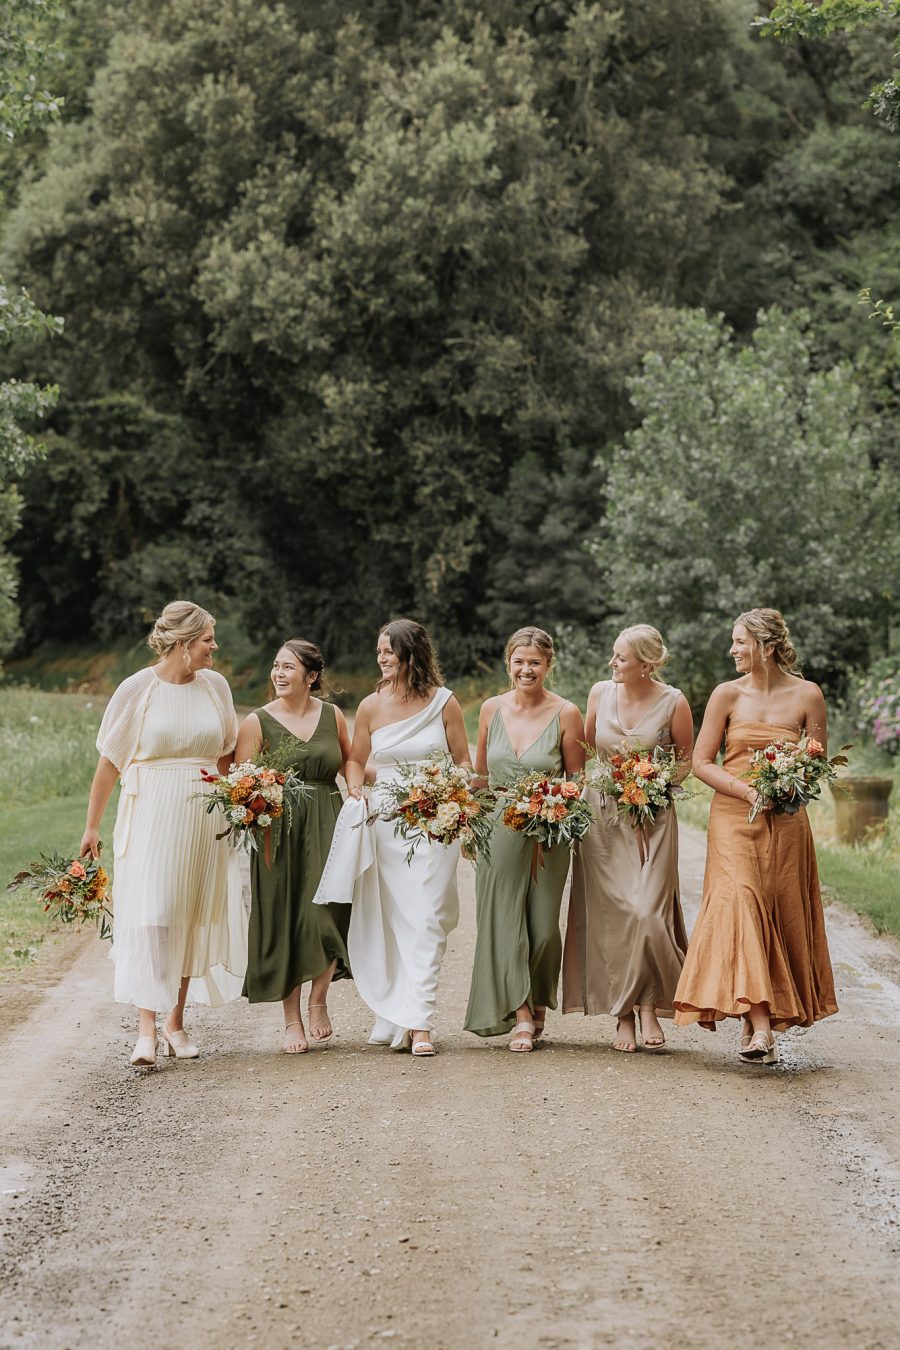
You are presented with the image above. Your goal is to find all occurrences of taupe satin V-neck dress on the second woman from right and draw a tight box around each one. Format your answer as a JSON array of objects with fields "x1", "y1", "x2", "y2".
[{"x1": 563, "y1": 680, "x2": 687, "y2": 1017}]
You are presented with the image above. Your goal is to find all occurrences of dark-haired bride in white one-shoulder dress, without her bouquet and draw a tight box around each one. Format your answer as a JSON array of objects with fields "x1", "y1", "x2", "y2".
[{"x1": 314, "y1": 618, "x2": 470, "y2": 1054}]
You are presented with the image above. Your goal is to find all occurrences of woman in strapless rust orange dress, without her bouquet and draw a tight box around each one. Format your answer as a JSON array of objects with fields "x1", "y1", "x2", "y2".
[{"x1": 675, "y1": 609, "x2": 838, "y2": 1064}]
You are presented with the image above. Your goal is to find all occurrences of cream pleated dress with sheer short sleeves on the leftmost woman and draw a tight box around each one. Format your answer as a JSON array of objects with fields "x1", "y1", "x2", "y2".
[{"x1": 97, "y1": 667, "x2": 247, "y2": 1011}]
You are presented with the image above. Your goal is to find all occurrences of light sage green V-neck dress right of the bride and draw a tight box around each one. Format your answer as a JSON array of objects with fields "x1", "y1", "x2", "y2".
[{"x1": 466, "y1": 707, "x2": 571, "y2": 1035}]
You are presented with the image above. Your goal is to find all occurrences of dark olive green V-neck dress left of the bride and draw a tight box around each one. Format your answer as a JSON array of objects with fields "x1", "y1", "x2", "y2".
[{"x1": 244, "y1": 703, "x2": 349, "y2": 1003}]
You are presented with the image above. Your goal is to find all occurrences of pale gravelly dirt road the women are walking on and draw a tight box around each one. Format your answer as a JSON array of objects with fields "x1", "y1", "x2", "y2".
[{"x1": 0, "y1": 830, "x2": 900, "y2": 1350}]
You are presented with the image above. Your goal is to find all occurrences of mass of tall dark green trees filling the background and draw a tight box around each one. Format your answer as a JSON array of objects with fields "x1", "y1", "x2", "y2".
[{"x1": 4, "y1": 0, "x2": 900, "y2": 691}]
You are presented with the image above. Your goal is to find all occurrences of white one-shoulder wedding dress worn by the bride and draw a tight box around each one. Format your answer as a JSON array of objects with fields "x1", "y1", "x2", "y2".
[{"x1": 313, "y1": 689, "x2": 459, "y2": 1049}]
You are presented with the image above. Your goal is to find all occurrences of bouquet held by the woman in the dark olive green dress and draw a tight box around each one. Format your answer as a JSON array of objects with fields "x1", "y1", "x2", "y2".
[{"x1": 193, "y1": 760, "x2": 309, "y2": 853}]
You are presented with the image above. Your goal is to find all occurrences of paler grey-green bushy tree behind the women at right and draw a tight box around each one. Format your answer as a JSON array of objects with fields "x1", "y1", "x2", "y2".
[{"x1": 595, "y1": 309, "x2": 900, "y2": 702}]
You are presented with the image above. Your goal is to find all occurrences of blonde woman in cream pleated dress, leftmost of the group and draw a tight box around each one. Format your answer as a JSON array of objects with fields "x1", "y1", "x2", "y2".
[{"x1": 81, "y1": 601, "x2": 246, "y2": 1065}]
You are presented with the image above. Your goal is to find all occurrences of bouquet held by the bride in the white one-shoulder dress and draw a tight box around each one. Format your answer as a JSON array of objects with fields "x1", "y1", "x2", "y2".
[{"x1": 368, "y1": 751, "x2": 494, "y2": 863}]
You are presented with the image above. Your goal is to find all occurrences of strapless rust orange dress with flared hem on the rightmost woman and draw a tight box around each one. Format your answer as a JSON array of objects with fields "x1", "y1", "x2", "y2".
[{"x1": 675, "y1": 718, "x2": 838, "y2": 1031}]
